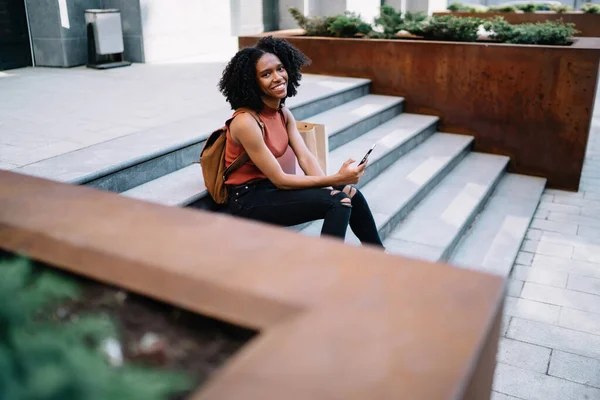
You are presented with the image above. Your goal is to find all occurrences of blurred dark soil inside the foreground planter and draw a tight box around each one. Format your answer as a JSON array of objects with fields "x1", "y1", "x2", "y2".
[{"x1": 53, "y1": 276, "x2": 256, "y2": 400}]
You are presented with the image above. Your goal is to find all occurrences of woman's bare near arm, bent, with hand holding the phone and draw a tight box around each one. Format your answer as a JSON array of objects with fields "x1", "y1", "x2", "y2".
[{"x1": 229, "y1": 113, "x2": 366, "y2": 189}]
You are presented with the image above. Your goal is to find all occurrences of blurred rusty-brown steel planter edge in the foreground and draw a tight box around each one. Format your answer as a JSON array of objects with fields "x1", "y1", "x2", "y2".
[{"x1": 0, "y1": 171, "x2": 505, "y2": 400}]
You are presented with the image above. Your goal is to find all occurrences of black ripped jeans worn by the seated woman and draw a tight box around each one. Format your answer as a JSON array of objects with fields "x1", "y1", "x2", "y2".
[{"x1": 228, "y1": 180, "x2": 383, "y2": 247}]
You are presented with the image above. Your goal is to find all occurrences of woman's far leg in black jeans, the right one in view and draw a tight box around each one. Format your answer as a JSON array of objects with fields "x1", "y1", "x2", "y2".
[{"x1": 334, "y1": 185, "x2": 383, "y2": 247}]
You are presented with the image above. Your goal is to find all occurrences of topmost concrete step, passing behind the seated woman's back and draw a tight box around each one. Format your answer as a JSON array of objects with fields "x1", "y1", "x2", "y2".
[{"x1": 15, "y1": 75, "x2": 370, "y2": 192}]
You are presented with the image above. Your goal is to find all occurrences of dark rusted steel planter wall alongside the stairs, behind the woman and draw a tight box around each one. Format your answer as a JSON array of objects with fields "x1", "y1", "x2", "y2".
[{"x1": 239, "y1": 31, "x2": 600, "y2": 191}]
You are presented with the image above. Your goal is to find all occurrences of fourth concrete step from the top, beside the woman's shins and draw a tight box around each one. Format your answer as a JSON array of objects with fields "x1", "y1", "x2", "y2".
[{"x1": 301, "y1": 133, "x2": 473, "y2": 244}]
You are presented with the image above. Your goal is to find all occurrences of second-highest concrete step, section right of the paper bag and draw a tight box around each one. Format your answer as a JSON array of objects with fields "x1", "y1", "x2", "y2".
[{"x1": 302, "y1": 94, "x2": 404, "y2": 151}]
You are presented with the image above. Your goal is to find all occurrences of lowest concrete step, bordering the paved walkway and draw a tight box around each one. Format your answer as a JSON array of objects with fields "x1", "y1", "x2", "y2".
[{"x1": 449, "y1": 174, "x2": 546, "y2": 277}]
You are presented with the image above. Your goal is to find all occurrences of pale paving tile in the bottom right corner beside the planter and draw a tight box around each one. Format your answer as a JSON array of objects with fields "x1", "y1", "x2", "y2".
[{"x1": 493, "y1": 363, "x2": 600, "y2": 400}]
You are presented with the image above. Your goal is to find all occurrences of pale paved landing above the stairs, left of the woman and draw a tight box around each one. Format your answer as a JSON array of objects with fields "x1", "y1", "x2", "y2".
[{"x1": 0, "y1": 54, "x2": 233, "y2": 170}]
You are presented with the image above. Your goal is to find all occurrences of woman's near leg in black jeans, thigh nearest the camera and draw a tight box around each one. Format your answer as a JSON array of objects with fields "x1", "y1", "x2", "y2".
[{"x1": 229, "y1": 185, "x2": 352, "y2": 239}]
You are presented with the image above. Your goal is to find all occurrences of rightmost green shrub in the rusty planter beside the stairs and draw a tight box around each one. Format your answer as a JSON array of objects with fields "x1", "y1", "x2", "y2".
[{"x1": 483, "y1": 17, "x2": 578, "y2": 45}]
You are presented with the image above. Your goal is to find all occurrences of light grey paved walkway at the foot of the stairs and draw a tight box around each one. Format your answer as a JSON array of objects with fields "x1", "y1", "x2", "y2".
[{"x1": 492, "y1": 96, "x2": 600, "y2": 400}]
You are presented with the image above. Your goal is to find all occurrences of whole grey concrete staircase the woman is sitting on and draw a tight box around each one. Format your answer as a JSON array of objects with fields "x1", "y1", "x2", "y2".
[{"x1": 22, "y1": 76, "x2": 545, "y2": 276}]
